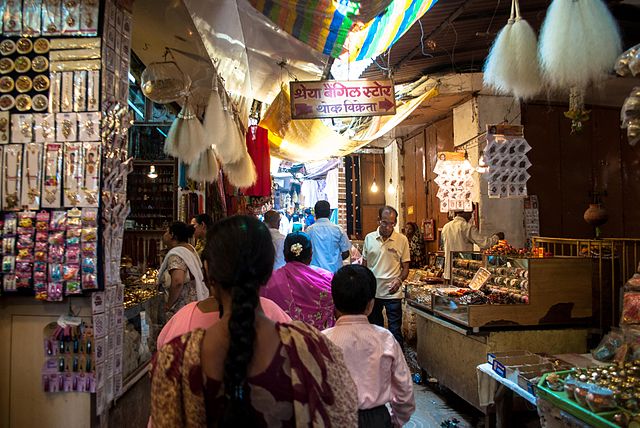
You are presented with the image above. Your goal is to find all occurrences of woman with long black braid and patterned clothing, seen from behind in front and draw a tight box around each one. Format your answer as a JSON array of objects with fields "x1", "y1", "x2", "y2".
[{"x1": 151, "y1": 216, "x2": 358, "y2": 428}]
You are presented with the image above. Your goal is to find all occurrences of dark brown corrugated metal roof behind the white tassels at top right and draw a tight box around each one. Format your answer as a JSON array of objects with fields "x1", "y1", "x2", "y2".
[{"x1": 362, "y1": 0, "x2": 640, "y2": 83}]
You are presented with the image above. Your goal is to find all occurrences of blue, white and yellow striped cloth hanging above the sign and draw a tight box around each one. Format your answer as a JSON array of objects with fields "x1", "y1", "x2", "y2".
[{"x1": 342, "y1": 0, "x2": 438, "y2": 61}]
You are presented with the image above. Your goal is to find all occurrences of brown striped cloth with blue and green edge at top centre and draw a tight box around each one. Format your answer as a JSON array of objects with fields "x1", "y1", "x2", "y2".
[{"x1": 249, "y1": 0, "x2": 358, "y2": 58}]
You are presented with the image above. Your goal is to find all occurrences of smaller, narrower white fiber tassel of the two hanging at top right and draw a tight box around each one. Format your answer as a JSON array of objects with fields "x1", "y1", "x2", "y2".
[{"x1": 509, "y1": 0, "x2": 542, "y2": 100}]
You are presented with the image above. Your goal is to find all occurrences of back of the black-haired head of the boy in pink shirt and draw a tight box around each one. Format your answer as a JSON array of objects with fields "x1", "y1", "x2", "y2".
[{"x1": 331, "y1": 265, "x2": 376, "y2": 315}]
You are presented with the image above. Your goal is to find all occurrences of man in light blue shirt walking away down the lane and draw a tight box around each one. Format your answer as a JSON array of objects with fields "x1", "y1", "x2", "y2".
[{"x1": 307, "y1": 201, "x2": 351, "y2": 273}]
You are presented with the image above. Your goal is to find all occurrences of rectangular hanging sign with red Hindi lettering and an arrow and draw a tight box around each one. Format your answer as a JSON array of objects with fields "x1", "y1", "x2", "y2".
[{"x1": 290, "y1": 80, "x2": 396, "y2": 119}]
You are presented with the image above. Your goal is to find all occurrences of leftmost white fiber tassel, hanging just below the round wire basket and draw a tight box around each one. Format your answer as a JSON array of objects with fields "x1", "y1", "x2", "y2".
[{"x1": 164, "y1": 100, "x2": 206, "y2": 164}]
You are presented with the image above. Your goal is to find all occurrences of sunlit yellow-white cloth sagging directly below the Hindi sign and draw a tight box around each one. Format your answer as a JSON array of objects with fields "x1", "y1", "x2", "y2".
[{"x1": 260, "y1": 86, "x2": 438, "y2": 162}]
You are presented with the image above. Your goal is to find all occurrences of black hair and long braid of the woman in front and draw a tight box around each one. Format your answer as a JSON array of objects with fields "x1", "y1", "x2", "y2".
[{"x1": 203, "y1": 216, "x2": 275, "y2": 427}]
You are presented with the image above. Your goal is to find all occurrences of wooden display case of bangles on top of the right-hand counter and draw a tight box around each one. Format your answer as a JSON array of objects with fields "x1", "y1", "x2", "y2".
[{"x1": 432, "y1": 253, "x2": 592, "y2": 329}]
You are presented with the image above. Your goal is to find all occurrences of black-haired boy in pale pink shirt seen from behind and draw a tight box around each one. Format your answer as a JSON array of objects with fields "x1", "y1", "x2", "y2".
[{"x1": 322, "y1": 265, "x2": 416, "y2": 428}]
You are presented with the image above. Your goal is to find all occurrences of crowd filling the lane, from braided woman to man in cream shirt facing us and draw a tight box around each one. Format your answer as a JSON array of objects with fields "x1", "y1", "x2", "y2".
[{"x1": 150, "y1": 206, "x2": 415, "y2": 428}]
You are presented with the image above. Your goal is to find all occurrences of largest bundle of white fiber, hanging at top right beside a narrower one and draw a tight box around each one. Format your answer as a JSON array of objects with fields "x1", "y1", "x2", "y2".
[{"x1": 538, "y1": 0, "x2": 622, "y2": 89}]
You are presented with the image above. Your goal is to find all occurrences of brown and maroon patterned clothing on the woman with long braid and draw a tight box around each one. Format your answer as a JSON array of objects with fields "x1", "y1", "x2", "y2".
[{"x1": 151, "y1": 322, "x2": 358, "y2": 428}]
